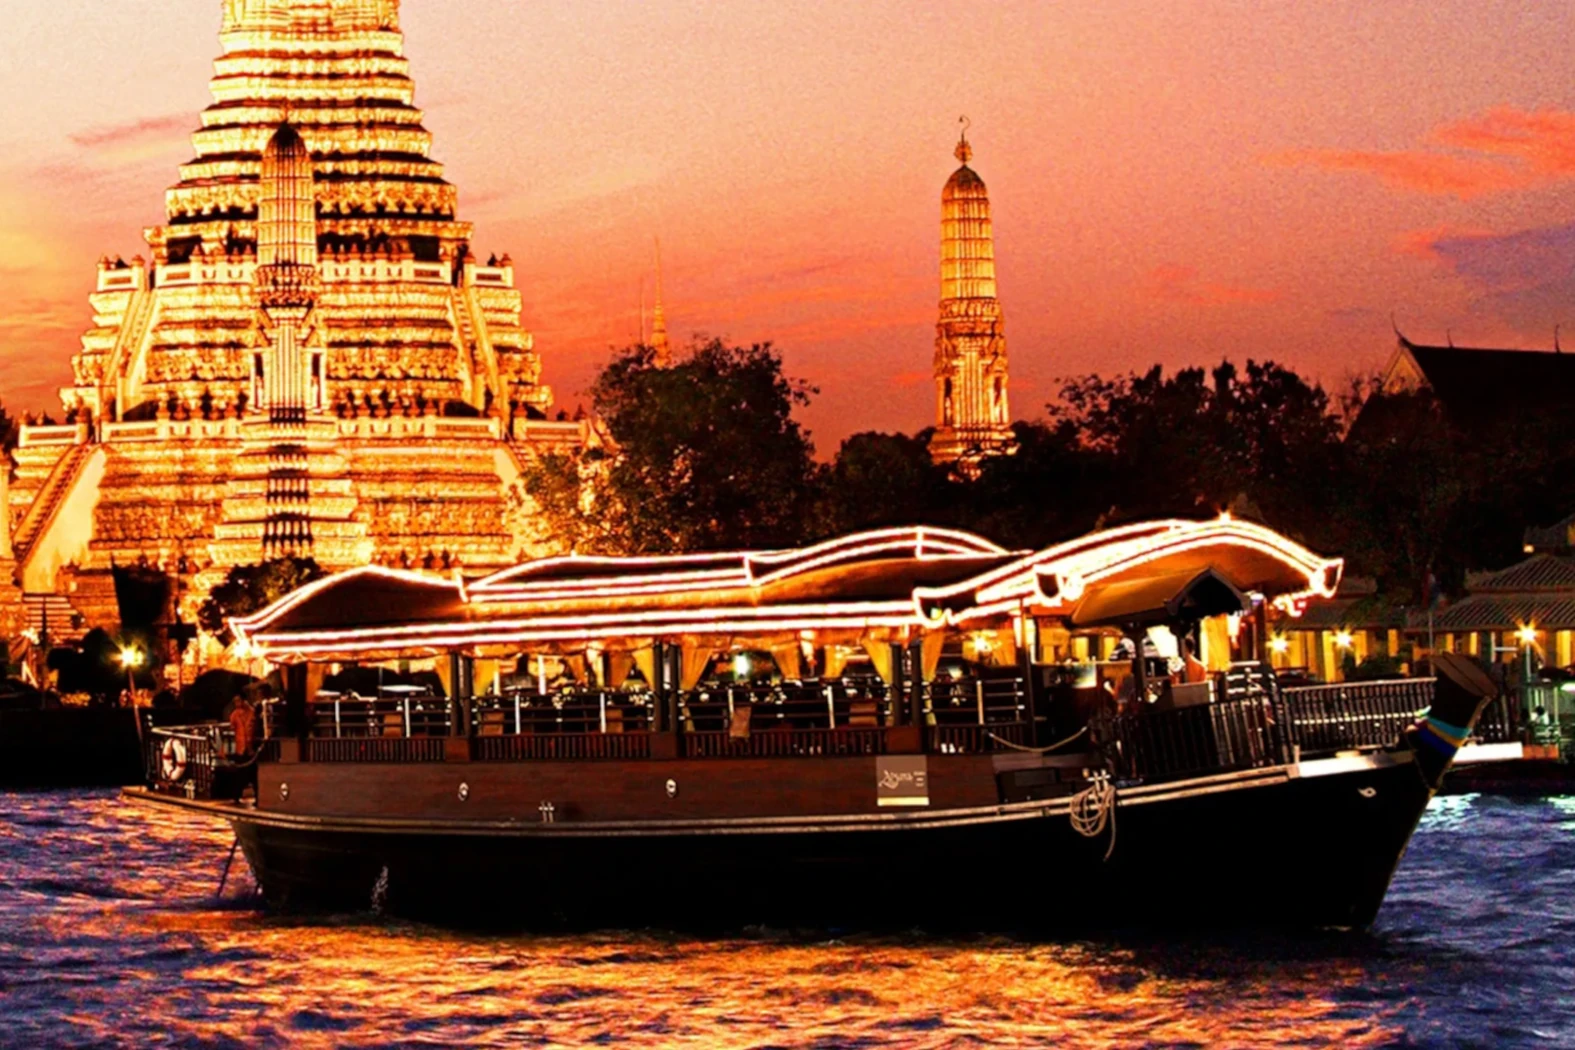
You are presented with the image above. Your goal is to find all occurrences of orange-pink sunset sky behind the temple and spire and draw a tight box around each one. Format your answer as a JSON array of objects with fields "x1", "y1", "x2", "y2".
[{"x1": 0, "y1": 0, "x2": 1575, "y2": 455}]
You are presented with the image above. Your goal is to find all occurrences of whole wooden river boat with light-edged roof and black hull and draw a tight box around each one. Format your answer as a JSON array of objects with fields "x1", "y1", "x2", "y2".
[{"x1": 122, "y1": 518, "x2": 1495, "y2": 929}]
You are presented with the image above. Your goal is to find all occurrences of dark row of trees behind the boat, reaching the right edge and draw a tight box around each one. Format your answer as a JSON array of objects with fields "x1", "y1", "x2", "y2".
[{"x1": 526, "y1": 349, "x2": 1575, "y2": 617}]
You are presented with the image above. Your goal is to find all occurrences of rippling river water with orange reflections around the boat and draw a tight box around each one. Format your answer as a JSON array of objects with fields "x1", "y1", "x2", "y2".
[{"x1": 0, "y1": 792, "x2": 1575, "y2": 1048}]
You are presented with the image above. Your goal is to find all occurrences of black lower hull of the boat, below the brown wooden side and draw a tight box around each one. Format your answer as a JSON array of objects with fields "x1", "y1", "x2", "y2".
[{"x1": 227, "y1": 752, "x2": 1432, "y2": 929}]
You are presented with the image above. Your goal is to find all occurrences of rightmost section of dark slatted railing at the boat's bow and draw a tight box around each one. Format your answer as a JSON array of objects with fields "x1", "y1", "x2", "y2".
[{"x1": 1280, "y1": 678, "x2": 1433, "y2": 754}]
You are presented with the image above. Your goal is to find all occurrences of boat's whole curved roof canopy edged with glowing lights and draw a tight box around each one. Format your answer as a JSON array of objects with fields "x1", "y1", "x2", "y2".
[{"x1": 233, "y1": 518, "x2": 1342, "y2": 661}]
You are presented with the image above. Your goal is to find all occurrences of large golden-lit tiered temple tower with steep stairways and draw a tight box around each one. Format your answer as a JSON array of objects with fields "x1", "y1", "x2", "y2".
[{"x1": 0, "y1": 0, "x2": 589, "y2": 651}]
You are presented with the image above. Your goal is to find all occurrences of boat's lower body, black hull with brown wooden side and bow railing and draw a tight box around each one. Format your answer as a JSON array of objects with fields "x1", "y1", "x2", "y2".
[{"x1": 137, "y1": 661, "x2": 1488, "y2": 930}]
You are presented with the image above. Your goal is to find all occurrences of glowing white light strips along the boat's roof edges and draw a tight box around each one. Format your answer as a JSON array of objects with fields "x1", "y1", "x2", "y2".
[{"x1": 232, "y1": 521, "x2": 1340, "y2": 660}]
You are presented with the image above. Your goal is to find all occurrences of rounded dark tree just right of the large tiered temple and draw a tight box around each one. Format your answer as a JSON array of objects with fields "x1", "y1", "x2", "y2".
[{"x1": 524, "y1": 340, "x2": 821, "y2": 553}]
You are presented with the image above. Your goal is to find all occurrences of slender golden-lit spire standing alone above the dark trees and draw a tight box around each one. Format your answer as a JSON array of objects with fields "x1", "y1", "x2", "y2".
[{"x1": 929, "y1": 118, "x2": 1014, "y2": 472}]
